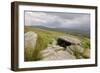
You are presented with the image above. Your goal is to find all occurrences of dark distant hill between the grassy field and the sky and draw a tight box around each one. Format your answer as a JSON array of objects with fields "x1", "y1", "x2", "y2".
[{"x1": 28, "y1": 26, "x2": 90, "y2": 37}]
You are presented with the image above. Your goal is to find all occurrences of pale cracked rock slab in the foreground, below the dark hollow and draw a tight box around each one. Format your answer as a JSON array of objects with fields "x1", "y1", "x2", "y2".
[{"x1": 41, "y1": 45, "x2": 75, "y2": 60}]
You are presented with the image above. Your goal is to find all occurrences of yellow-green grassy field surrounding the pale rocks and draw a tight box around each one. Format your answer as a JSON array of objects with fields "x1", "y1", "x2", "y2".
[{"x1": 24, "y1": 26, "x2": 90, "y2": 61}]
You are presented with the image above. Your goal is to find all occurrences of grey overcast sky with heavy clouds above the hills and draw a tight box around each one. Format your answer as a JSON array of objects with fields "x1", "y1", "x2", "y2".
[{"x1": 25, "y1": 11, "x2": 90, "y2": 29}]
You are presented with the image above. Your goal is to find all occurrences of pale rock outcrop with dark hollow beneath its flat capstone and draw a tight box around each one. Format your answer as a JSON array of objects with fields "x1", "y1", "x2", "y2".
[{"x1": 41, "y1": 36, "x2": 89, "y2": 60}]
